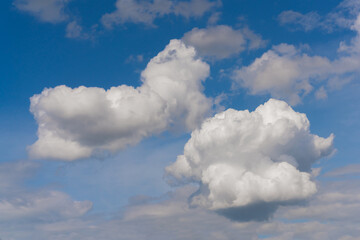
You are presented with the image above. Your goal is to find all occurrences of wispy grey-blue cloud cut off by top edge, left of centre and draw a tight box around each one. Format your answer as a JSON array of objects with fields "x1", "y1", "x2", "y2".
[{"x1": 101, "y1": 0, "x2": 221, "y2": 28}]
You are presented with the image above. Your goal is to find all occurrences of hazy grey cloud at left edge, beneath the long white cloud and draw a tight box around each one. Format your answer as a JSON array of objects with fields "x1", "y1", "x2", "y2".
[{"x1": 0, "y1": 161, "x2": 92, "y2": 224}]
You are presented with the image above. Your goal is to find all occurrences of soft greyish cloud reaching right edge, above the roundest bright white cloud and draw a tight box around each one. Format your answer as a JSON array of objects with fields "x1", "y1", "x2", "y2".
[{"x1": 233, "y1": 15, "x2": 360, "y2": 105}]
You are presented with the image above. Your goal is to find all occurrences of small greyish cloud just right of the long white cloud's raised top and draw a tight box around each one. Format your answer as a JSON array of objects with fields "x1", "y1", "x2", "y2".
[{"x1": 182, "y1": 25, "x2": 264, "y2": 59}]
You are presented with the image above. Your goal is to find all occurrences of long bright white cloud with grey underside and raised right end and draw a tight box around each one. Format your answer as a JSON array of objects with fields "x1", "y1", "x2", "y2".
[{"x1": 29, "y1": 40, "x2": 211, "y2": 160}]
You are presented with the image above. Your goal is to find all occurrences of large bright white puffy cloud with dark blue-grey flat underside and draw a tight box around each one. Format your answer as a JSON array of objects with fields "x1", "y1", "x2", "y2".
[{"x1": 166, "y1": 99, "x2": 334, "y2": 220}]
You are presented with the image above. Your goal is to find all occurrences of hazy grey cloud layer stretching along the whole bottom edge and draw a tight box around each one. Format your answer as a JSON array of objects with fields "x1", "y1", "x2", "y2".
[{"x1": 4, "y1": 181, "x2": 360, "y2": 240}]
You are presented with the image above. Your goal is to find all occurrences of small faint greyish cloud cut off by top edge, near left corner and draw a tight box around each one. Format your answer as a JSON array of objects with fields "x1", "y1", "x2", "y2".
[{"x1": 14, "y1": 0, "x2": 69, "y2": 23}]
